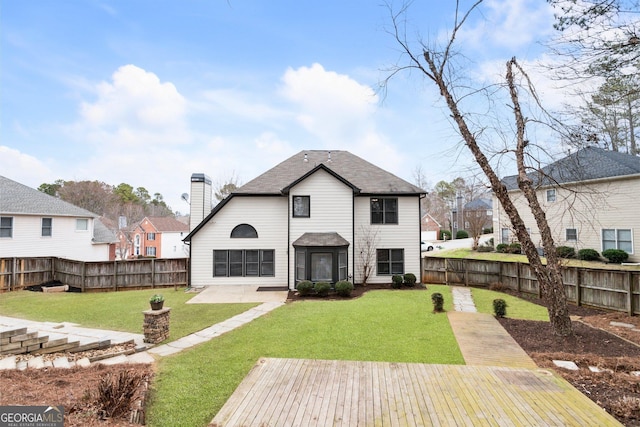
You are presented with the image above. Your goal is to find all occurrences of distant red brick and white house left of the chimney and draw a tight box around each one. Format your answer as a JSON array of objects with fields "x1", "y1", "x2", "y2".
[{"x1": 126, "y1": 217, "x2": 189, "y2": 258}]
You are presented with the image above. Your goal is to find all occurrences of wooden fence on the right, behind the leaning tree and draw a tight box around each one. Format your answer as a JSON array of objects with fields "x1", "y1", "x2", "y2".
[{"x1": 422, "y1": 257, "x2": 640, "y2": 315}]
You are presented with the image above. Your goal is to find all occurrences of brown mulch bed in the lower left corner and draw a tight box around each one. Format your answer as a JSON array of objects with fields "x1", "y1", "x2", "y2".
[{"x1": 0, "y1": 364, "x2": 153, "y2": 427}]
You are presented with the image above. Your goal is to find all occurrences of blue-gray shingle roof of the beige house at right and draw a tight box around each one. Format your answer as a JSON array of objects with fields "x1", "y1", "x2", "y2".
[{"x1": 502, "y1": 147, "x2": 640, "y2": 190}]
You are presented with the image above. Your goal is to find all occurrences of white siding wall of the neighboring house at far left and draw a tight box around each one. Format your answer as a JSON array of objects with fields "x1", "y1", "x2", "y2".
[{"x1": 0, "y1": 215, "x2": 109, "y2": 261}]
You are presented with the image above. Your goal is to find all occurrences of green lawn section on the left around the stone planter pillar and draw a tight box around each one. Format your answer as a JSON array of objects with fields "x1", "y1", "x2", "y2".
[{"x1": 0, "y1": 288, "x2": 258, "y2": 341}]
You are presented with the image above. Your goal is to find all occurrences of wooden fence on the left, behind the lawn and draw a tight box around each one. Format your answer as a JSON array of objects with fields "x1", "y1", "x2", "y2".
[{"x1": 0, "y1": 257, "x2": 189, "y2": 292}]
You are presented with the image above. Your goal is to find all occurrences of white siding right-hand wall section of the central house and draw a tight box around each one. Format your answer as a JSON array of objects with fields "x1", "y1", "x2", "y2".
[{"x1": 354, "y1": 196, "x2": 421, "y2": 283}]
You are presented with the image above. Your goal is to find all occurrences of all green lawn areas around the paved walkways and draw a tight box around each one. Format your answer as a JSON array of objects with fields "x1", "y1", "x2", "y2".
[{"x1": 0, "y1": 285, "x2": 546, "y2": 426}]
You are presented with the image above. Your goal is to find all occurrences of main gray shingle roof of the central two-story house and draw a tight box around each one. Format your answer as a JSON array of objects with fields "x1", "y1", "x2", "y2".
[{"x1": 234, "y1": 150, "x2": 425, "y2": 194}]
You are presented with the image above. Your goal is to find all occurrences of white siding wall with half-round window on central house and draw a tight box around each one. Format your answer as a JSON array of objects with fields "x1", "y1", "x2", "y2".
[{"x1": 191, "y1": 196, "x2": 288, "y2": 287}]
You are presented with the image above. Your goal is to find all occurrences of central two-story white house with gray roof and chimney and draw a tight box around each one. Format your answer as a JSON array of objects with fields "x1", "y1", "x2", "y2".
[{"x1": 185, "y1": 150, "x2": 425, "y2": 289}]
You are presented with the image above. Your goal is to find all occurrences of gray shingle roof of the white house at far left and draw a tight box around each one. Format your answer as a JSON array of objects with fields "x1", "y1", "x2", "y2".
[{"x1": 0, "y1": 175, "x2": 98, "y2": 218}]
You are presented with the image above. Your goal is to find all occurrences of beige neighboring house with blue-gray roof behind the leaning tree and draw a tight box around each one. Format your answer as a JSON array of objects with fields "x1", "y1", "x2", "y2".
[{"x1": 494, "y1": 147, "x2": 640, "y2": 262}]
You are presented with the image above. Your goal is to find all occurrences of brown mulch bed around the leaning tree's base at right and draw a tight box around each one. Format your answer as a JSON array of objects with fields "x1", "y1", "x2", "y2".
[{"x1": 499, "y1": 297, "x2": 640, "y2": 426}]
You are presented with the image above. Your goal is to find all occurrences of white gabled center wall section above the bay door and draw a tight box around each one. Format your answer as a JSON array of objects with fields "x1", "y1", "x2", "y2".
[{"x1": 283, "y1": 170, "x2": 353, "y2": 287}]
